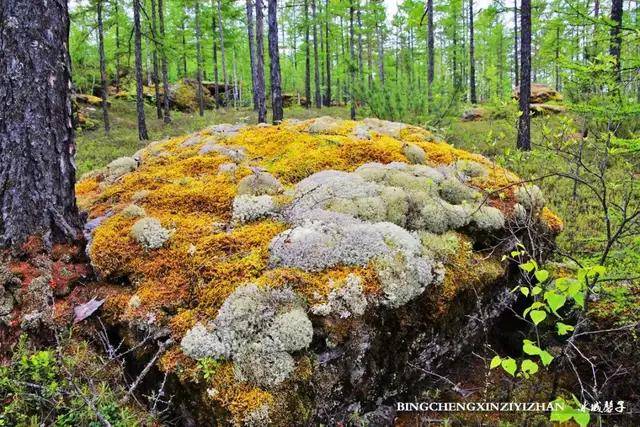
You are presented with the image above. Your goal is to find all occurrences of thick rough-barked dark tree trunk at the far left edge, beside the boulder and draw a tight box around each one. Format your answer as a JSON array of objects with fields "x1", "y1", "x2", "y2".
[{"x1": 0, "y1": 0, "x2": 82, "y2": 249}]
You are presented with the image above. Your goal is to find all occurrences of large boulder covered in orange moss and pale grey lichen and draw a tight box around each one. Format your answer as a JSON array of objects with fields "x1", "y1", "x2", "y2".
[{"x1": 77, "y1": 117, "x2": 562, "y2": 425}]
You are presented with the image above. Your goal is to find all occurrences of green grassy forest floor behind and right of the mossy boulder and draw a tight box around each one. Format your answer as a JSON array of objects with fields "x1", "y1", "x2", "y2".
[{"x1": 77, "y1": 100, "x2": 640, "y2": 323}]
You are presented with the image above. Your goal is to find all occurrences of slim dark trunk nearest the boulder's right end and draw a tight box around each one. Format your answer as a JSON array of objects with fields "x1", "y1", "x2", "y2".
[{"x1": 517, "y1": 0, "x2": 531, "y2": 151}]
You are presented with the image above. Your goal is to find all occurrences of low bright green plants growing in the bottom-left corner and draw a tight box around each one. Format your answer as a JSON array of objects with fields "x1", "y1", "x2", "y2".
[{"x1": 0, "y1": 336, "x2": 141, "y2": 427}]
